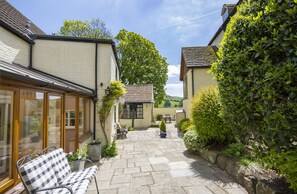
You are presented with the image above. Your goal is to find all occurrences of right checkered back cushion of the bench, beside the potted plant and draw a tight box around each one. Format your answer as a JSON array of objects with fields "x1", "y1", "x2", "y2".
[{"x1": 46, "y1": 148, "x2": 71, "y2": 183}]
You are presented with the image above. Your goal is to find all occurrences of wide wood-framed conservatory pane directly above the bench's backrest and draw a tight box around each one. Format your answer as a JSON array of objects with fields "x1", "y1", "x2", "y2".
[{"x1": 19, "y1": 90, "x2": 44, "y2": 158}]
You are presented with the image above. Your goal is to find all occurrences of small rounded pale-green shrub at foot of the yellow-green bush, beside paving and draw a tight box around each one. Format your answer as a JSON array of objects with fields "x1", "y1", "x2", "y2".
[{"x1": 184, "y1": 130, "x2": 204, "y2": 151}]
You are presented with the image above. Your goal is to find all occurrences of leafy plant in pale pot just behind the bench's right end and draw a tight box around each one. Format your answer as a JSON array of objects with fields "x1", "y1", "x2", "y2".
[{"x1": 67, "y1": 146, "x2": 88, "y2": 171}]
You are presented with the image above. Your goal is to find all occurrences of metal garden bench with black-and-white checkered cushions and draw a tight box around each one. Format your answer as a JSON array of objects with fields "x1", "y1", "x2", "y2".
[{"x1": 16, "y1": 147, "x2": 99, "y2": 194}]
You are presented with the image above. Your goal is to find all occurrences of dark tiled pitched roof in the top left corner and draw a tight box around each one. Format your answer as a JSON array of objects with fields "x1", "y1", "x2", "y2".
[{"x1": 0, "y1": 0, "x2": 45, "y2": 39}]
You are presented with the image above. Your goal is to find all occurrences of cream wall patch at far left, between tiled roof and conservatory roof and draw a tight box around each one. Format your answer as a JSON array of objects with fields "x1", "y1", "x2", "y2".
[{"x1": 0, "y1": 27, "x2": 30, "y2": 67}]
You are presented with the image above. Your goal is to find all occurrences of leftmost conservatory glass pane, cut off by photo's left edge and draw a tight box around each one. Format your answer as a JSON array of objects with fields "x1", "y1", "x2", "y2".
[{"x1": 0, "y1": 90, "x2": 13, "y2": 186}]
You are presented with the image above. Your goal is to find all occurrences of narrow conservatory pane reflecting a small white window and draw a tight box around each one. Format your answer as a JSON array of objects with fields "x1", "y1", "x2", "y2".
[{"x1": 65, "y1": 96, "x2": 76, "y2": 152}]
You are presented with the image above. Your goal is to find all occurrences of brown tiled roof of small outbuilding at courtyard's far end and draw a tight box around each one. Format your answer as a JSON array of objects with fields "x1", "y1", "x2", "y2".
[{"x1": 123, "y1": 85, "x2": 154, "y2": 103}]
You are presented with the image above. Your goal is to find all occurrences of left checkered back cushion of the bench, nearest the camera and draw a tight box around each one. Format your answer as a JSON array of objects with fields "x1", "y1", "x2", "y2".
[{"x1": 20, "y1": 155, "x2": 58, "y2": 193}]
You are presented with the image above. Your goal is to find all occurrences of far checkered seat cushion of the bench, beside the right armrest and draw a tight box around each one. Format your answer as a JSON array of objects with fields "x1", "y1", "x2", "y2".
[{"x1": 62, "y1": 166, "x2": 98, "y2": 185}]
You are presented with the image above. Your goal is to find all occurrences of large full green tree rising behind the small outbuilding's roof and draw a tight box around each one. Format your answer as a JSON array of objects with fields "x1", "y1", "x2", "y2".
[{"x1": 115, "y1": 29, "x2": 168, "y2": 104}]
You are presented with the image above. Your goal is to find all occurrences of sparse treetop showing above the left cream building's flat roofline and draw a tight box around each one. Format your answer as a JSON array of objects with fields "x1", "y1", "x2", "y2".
[{"x1": 56, "y1": 18, "x2": 113, "y2": 39}]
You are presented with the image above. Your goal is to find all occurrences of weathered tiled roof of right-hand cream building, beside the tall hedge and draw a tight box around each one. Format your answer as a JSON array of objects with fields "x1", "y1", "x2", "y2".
[{"x1": 182, "y1": 46, "x2": 217, "y2": 67}]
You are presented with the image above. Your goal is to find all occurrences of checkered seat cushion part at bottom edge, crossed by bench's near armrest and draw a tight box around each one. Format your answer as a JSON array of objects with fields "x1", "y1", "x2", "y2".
[{"x1": 52, "y1": 179, "x2": 90, "y2": 194}]
